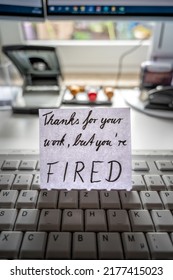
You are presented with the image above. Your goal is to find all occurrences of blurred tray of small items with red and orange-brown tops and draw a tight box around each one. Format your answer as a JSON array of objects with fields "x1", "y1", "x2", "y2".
[{"x1": 62, "y1": 85, "x2": 114, "y2": 106}]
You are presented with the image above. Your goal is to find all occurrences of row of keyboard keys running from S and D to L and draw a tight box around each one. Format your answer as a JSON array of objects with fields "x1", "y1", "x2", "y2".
[{"x1": 0, "y1": 209, "x2": 173, "y2": 232}]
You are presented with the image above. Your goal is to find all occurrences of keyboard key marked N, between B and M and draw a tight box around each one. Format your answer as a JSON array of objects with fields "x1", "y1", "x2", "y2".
[{"x1": 97, "y1": 232, "x2": 124, "y2": 260}]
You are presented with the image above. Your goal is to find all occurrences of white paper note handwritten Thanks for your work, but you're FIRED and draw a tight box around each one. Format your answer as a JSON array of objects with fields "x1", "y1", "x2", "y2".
[{"x1": 39, "y1": 108, "x2": 131, "y2": 190}]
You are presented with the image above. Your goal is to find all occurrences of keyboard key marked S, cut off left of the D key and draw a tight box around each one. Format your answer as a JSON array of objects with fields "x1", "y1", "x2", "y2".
[{"x1": 0, "y1": 209, "x2": 17, "y2": 231}]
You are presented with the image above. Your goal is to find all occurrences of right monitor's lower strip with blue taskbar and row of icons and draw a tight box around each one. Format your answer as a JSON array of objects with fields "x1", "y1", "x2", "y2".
[{"x1": 46, "y1": 0, "x2": 173, "y2": 20}]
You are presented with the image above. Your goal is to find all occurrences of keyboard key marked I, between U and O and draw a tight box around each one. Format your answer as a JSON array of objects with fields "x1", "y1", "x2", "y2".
[{"x1": 120, "y1": 191, "x2": 142, "y2": 209}]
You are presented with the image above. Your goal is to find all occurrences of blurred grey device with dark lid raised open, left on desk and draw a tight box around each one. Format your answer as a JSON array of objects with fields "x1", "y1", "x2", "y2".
[{"x1": 2, "y1": 45, "x2": 64, "y2": 113}]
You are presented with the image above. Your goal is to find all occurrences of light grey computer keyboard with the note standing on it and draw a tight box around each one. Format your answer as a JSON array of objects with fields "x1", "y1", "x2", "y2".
[{"x1": 0, "y1": 150, "x2": 173, "y2": 260}]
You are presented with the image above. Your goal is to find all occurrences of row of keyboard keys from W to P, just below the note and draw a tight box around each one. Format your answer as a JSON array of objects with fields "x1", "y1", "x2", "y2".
[{"x1": 0, "y1": 190, "x2": 173, "y2": 210}]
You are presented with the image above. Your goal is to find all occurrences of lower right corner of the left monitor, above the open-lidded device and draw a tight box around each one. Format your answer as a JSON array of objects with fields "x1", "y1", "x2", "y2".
[{"x1": 0, "y1": 0, "x2": 44, "y2": 21}]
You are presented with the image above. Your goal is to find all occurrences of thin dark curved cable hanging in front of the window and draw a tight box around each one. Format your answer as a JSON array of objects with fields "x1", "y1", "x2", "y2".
[{"x1": 116, "y1": 38, "x2": 148, "y2": 88}]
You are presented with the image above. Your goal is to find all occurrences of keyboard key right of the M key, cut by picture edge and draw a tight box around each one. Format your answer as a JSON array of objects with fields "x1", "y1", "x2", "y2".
[{"x1": 146, "y1": 232, "x2": 173, "y2": 259}]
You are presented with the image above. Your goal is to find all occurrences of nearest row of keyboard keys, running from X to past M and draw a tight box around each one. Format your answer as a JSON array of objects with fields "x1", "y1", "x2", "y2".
[{"x1": 0, "y1": 231, "x2": 173, "y2": 259}]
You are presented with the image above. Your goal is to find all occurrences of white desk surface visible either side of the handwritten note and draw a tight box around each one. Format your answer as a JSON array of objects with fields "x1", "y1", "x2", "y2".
[{"x1": 0, "y1": 91, "x2": 173, "y2": 150}]
